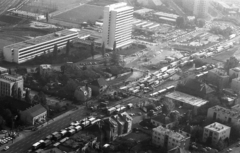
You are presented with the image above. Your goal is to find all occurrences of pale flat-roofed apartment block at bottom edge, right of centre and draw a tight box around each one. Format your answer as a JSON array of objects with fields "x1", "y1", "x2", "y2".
[{"x1": 152, "y1": 126, "x2": 190, "y2": 150}]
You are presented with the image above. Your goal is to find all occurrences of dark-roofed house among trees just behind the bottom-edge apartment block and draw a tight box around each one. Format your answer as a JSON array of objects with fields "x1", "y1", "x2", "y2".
[{"x1": 151, "y1": 114, "x2": 175, "y2": 129}]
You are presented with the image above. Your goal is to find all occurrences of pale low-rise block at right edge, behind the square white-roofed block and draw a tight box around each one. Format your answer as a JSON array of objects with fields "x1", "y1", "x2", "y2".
[{"x1": 207, "y1": 105, "x2": 240, "y2": 124}]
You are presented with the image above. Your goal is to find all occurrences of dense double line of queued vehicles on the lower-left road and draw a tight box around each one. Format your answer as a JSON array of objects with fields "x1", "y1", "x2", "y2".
[{"x1": 28, "y1": 116, "x2": 100, "y2": 153}]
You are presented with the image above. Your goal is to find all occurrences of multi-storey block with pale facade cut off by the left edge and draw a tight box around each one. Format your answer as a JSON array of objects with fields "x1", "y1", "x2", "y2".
[{"x1": 0, "y1": 74, "x2": 24, "y2": 97}]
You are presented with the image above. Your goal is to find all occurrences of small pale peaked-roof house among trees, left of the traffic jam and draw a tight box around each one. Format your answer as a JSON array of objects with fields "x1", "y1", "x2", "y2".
[{"x1": 74, "y1": 86, "x2": 92, "y2": 102}]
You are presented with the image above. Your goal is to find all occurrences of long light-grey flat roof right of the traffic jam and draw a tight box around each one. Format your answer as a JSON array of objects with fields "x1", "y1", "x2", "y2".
[{"x1": 166, "y1": 91, "x2": 208, "y2": 107}]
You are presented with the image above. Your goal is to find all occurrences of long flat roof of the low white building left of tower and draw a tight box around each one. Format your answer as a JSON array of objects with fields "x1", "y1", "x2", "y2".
[{"x1": 4, "y1": 29, "x2": 77, "y2": 50}]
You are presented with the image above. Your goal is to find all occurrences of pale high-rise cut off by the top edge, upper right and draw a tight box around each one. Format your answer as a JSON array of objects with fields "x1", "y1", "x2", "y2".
[{"x1": 193, "y1": 0, "x2": 209, "y2": 18}]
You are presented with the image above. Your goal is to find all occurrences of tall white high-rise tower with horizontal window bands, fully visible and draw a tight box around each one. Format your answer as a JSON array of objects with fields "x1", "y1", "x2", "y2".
[{"x1": 103, "y1": 3, "x2": 133, "y2": 49}]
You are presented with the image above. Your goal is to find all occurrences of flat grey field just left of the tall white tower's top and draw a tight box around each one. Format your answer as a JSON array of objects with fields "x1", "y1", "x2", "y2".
[{"x1": 54, "y1": 5, "x2": 103, "y2": 24}]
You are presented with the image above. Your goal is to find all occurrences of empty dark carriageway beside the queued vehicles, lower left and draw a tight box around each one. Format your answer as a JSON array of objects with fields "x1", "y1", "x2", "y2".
[{"x1": 1, "y1": 107, "x2": 87, "y2": 153}]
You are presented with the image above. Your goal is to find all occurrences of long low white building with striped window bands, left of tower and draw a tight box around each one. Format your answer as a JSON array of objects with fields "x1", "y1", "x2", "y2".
[{"x1": 3, "y1": 29, "x2": 78, "y2": 63}]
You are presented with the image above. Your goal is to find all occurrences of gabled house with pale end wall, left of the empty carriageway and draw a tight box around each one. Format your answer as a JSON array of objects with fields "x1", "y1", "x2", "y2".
[{"x1": 20, "y1": 104, "x2": 47, "y2": 125}]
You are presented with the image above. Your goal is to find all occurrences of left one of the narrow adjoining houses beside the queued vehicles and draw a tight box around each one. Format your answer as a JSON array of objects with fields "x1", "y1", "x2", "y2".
[{"x1": 102, "y1": 117, "x2": 118, "y2": 142}]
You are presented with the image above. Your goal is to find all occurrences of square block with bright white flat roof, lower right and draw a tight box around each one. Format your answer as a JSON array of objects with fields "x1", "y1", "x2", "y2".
[{"x1": 203, "y1": 122, "x2": 231, "y2": 144}]
